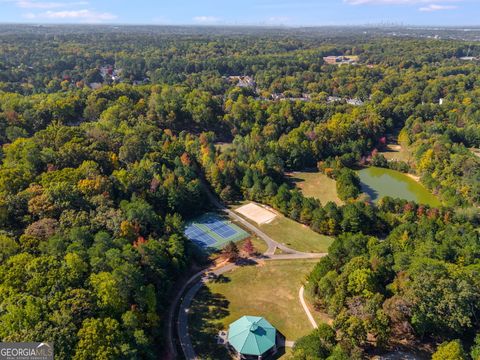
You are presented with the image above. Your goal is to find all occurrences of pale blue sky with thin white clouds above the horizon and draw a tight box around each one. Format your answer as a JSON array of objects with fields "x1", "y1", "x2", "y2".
[{"x1": 0, "y1": 0, "x2": 480, "y2": 26}]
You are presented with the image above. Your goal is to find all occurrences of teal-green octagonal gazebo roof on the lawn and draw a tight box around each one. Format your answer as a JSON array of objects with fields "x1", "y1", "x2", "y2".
[{"x1": 228, "y1": 316, "x2": 276, "y2": 356}]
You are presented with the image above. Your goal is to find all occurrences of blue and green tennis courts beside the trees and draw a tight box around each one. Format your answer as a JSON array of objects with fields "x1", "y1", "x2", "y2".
[{"x1": 185, "y1": 213, "x2": 249, "y2": 249}]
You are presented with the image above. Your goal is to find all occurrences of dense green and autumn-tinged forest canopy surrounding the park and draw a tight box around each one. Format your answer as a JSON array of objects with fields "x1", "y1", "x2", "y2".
[{"x1": 0, "y1": 26, "x2": 480, "y2": 359}]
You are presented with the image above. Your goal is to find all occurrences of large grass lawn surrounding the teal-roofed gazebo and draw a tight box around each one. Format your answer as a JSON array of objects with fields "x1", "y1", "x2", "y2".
[{"x1": 189, "y1": 260, "x2": 318, "y2": 359}]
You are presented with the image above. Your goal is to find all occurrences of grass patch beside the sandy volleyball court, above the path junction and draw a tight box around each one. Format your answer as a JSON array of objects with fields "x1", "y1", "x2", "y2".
[{"x1": 259, "y1": 215, "x2": 333, "y2": 252}]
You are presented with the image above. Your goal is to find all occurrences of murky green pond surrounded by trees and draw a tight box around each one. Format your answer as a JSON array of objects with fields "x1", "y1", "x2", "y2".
[{"x1": 358, "y1": 167, "x2": 440, "y2": 206}]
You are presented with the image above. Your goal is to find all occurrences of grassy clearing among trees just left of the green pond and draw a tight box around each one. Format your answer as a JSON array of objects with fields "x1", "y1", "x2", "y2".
[{"x1": 287, "y1": 172, "x2": 343, "y2": 205}]
